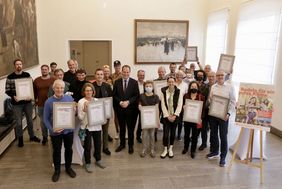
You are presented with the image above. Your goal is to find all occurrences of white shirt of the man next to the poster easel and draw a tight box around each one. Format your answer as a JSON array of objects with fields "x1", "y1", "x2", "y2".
[{"x1": 209, "y1": 82, "x2": 236, "y2": 114}]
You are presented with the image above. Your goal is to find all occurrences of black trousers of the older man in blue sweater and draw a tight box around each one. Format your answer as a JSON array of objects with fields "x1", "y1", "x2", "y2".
[{"x1": 51, "y1": 132, "x2": 73, "y2": 172}]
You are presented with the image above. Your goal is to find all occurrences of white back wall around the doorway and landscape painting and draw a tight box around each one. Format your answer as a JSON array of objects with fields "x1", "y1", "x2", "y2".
[{"x1": 36, "y1": 0, "x2": 206, "y2": 79}]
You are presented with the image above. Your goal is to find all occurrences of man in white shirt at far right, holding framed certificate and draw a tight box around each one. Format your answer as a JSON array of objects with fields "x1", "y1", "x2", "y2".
[{"x1": 207, "y1": 70, "x2": 236, "y2": 167}]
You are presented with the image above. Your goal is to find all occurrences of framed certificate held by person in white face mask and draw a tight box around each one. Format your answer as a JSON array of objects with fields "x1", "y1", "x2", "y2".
[{"x1": 140, "y1": 105, "x2": 160, "y2": 129}]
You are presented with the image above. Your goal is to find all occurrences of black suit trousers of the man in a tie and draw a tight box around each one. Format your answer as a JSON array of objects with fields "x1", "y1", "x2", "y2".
[{"x1": 118, "y1": 112, "x2": 138, "y2": 146}]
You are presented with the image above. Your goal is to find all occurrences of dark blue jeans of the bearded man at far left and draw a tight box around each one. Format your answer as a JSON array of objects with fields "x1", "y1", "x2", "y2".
[{"x1": 13, "y1": 102, "x2": 34, "y2": 138}]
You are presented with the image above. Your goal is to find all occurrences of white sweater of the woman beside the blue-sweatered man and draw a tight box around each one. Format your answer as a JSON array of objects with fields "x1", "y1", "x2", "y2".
[{"x1": 77, "y1": 98, "x2": 102, "y2": 131}]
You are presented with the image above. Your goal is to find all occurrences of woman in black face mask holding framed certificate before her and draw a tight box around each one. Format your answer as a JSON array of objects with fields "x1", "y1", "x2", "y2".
[{"x1": 182, "y1": 81, "x2": 205, "y2": 159}]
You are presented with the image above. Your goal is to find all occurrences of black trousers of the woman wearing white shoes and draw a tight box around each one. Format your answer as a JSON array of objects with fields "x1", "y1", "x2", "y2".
[{"x1": 163, "y1": 118, "x2": 177, "y2": 147}]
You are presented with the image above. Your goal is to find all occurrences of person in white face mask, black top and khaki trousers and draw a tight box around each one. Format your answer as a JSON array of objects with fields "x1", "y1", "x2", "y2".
[{"x1": 139, "y1": 81, "x2": 160, "y2": 158}]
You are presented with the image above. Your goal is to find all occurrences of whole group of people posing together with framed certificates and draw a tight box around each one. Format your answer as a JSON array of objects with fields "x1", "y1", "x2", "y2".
[{"x1": 6, "y1": 59, "x2": 235, "y2": 182}]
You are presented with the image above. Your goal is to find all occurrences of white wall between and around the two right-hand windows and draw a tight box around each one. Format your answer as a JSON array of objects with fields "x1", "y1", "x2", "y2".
[{"x1": 207, "y1": 0, "x2": 282, "y2": 131}]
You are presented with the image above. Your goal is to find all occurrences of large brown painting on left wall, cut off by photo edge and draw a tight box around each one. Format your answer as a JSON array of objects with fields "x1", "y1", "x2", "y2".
[{"x1": 0, "y1": 0, "x2": 39, "y2": 78}]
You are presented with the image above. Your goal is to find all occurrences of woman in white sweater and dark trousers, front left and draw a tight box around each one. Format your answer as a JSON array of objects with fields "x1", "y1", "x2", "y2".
[{"x1": 78, "y1": 83, "x2": 105, "y2": 173}]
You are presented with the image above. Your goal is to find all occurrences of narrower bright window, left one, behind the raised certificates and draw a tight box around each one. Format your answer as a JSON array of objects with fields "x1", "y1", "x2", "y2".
[{"x1": 205, "y1": 9, "x2": 229, "y2": 70}]
